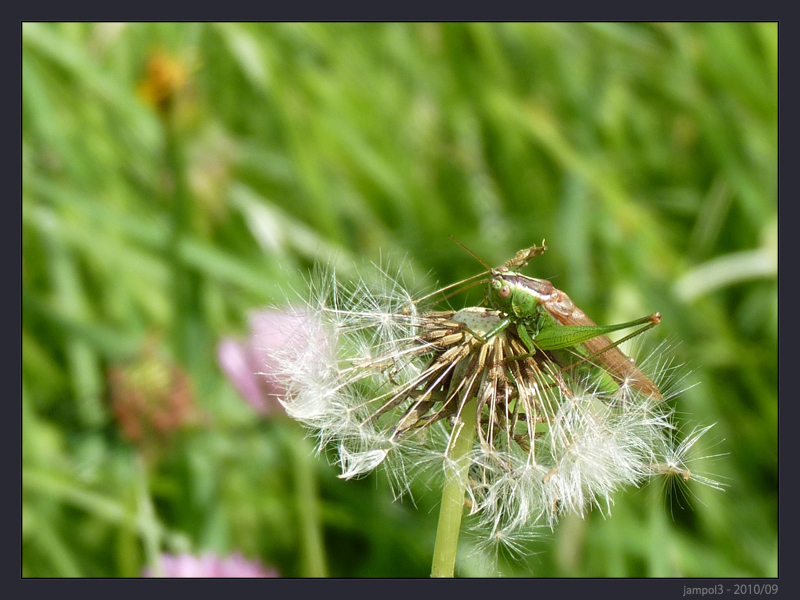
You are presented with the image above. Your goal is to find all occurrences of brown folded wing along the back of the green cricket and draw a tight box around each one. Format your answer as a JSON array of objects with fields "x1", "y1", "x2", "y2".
[{"x1": 542, "y1": 282, "x2": 663, "y2": 401}]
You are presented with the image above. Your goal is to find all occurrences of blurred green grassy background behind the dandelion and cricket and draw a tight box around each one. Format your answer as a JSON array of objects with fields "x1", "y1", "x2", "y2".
[{"x1": 22, "y1": 23, "x2": 778, "y2": 577}]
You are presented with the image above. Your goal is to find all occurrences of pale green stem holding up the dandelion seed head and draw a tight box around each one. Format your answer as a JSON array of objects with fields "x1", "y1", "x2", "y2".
[{"x1": 431, "y1": 398, "x2": 478, "y2": 577}]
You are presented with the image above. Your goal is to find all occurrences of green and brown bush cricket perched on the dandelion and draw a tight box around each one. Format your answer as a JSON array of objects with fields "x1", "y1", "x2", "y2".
[{"x1": 451, "y1": 236, "x2": 663, "y2": 401}]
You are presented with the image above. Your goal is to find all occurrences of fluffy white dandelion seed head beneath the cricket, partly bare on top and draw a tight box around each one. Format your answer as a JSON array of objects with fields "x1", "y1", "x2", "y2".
[{"x1": 271, "y1": 256, "x2": 720, "y2": 551}]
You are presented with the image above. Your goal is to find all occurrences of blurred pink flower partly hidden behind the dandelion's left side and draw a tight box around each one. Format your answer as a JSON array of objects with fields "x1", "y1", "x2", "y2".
[{"x1": 217, "y1": 309, "x2": 305, "y2": 415}]
